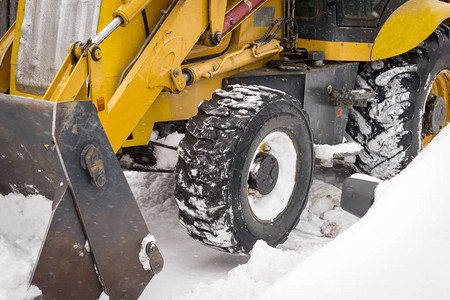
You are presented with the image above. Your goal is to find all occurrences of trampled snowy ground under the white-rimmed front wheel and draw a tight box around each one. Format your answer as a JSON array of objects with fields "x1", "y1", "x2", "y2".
[{"x1": 130, "y1": 172, "x2": 357, "y2": 300}]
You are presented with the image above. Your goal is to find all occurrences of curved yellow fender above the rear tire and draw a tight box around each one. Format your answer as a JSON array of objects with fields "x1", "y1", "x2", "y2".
[{"x1": 371, "y1": 0, "x2": 450, "y2": 60}]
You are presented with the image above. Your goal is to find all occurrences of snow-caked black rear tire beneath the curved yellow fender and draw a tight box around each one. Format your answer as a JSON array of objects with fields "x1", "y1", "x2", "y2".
[{"x1": 347, "y1": 25, "x2": 450, "y2": 179}]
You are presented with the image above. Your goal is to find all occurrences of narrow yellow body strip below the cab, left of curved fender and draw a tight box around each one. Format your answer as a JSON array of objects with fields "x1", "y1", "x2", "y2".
[{"x1": 298, "y1": 39, "x2": 373, "y2": 61}]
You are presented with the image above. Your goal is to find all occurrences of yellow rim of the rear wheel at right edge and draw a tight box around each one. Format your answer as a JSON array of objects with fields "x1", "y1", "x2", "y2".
[{"x1": 422, "y1": 70, "x2": 450, "y2": 148}]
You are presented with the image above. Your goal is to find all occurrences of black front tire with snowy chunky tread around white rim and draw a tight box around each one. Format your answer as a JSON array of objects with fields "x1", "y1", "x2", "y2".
[{"x1": 175, "y1": 85, "x2": 314, "y2": 253}]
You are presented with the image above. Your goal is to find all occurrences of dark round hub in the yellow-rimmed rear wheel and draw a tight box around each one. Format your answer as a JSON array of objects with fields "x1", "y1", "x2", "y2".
[{"x1": 423, "y1": 96, "x2": 446, "y2": 135}]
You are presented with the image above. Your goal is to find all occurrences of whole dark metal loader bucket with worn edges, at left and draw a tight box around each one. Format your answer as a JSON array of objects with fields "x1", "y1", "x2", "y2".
[{"x1": 0, "y1": 95, "x2": 163, "y2": 299}]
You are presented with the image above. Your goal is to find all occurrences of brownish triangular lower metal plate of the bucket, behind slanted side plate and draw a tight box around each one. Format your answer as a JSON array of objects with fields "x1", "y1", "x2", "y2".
[{"x1": 31, "y1": 189, "x2": 103, "y2": 300}]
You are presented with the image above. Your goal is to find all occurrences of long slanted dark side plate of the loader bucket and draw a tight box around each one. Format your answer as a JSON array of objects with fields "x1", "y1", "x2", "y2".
[{"x1": 55, "y1": 101, "x2": 153, "y2": 299}]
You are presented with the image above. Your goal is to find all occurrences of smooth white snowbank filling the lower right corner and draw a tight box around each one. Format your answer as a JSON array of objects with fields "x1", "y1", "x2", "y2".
[{"x1": 260, "y1": 127, "x2": 450, "y2": 300}]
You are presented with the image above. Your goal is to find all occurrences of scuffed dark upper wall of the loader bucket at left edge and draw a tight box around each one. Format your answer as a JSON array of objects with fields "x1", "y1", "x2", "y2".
[{"x1": 0, "y1": 95, "x2": 65, "y2": 199}]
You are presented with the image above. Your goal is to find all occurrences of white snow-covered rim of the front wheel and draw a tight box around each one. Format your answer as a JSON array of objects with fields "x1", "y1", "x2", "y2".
[{"x1": 247, "y1": 131, "x2": 297, "y2": 222}]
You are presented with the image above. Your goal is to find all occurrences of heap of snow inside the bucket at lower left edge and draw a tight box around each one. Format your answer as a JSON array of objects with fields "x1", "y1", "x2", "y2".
[{"x1": 0, "y1": 194, "x2": 52, "y2": 300}]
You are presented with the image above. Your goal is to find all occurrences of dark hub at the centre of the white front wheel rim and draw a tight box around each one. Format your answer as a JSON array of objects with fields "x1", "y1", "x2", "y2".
[{"x1": 249, "y1": 152, "x2": 279, "y2": 195}]
